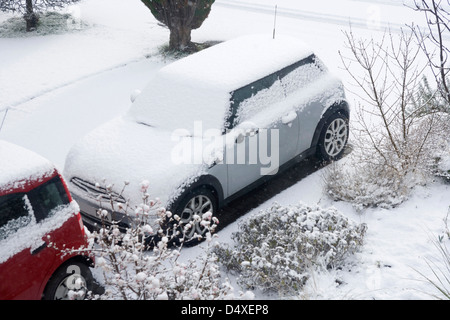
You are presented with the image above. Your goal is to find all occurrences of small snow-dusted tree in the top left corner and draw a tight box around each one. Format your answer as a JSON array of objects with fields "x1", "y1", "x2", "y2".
[{"x1": 0, "y1": 0, "x2": 79, "y2": 31}]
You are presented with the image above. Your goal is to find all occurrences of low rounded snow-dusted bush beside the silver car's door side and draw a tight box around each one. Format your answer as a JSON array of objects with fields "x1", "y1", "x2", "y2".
[{"x1": 215, "y1": 203, "x2": 366, "y2": 296}]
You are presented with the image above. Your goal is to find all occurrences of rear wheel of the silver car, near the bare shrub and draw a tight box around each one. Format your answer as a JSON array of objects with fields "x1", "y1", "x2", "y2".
[{"x1": 318, "y1": 112, "x2": 349, "y2": 161}]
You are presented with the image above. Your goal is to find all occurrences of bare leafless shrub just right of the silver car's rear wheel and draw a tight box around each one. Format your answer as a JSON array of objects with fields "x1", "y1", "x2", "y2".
[{"x1": 341, "y1": 31, "x2": 436, "y2": 175}]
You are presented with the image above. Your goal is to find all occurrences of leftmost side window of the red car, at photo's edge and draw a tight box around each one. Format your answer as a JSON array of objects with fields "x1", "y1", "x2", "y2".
[{"x1": 0, "y1": 193, "x2": 34, "y2": 240}]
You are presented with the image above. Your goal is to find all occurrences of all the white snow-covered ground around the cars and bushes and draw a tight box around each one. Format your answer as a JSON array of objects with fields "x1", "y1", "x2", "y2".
[{"x1": 0, "y1": 0, "x2": 450, "y2": 299}]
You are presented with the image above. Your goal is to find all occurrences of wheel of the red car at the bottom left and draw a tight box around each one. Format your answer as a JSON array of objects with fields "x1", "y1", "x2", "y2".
[{"x1": 43, "y1": 262, "x2": 93, "y2": 300}]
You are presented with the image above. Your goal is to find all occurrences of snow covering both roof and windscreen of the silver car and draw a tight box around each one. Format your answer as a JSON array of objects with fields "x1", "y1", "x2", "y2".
[{"x1": 128, "y1": 35, "x2": 312, "y2": 134}]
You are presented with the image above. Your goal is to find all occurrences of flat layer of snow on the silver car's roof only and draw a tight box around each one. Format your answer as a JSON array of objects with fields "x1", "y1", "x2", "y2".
[{"x1": 155, "y1": 34, "x2": 312, "y2": 92}]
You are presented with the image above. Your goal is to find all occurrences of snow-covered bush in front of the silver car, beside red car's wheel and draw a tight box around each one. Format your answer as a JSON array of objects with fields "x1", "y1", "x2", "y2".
[{"x1": 89, "y1": 183, "x2": 252, "y2": 300}]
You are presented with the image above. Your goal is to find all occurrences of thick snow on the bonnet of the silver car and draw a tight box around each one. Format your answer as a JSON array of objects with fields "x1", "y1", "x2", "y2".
[{"x1": 64, "y1": 117, "x2": 207, "y2": 206}]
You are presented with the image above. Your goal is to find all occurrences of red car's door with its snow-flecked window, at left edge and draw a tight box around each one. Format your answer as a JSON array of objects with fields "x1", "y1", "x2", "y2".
[{"x1": 0, "y1": 193, "x2": 55, "y2": 300}]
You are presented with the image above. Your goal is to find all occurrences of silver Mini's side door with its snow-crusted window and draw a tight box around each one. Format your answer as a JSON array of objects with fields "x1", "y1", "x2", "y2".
[{"x1": 225, "y1": 74, "x2": 298, "y2": 195}]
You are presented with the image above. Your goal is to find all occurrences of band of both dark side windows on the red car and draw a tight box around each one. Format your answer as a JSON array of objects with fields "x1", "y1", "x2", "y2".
[{"x1": 0, "y1": 176, "x2": 69, "y2": 240}]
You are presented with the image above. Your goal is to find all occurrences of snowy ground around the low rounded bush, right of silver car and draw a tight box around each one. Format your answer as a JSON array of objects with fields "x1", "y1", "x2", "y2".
[{"x1": 230, "y1": 159, "x2": 450, "y2": 300}]
